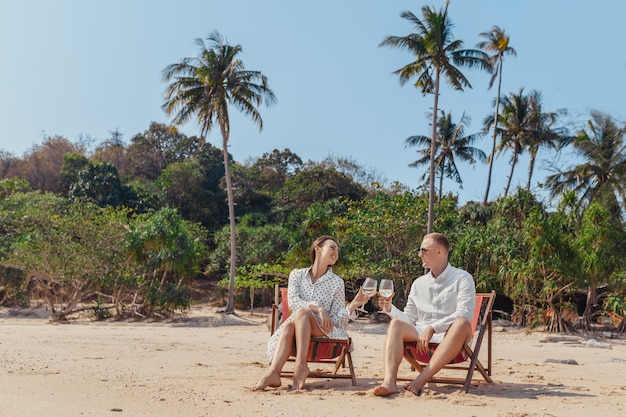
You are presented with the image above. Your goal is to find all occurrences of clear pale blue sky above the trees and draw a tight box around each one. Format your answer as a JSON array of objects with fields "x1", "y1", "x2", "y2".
[{"x1": 0, "y1": 0, "x2": 626, "y2": 203}]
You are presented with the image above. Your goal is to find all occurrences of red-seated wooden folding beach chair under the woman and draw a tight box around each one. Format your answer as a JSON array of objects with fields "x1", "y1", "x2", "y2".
[{"x1": 270, "y1": 285, "x2": 356, "y2": 385}]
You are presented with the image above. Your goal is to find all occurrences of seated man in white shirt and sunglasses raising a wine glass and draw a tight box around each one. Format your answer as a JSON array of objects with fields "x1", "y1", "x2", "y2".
[{"x1": 374, "y1": 233, "x2": 476, "y2": 397}]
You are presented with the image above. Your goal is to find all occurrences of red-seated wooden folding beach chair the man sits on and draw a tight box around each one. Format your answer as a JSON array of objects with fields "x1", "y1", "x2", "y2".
[{"x1": 398, "y1": 291, "x2": 496, "y2": 392}]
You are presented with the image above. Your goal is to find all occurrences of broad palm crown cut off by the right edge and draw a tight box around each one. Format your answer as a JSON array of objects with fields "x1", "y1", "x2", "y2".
[{"x1": 546, "y1": 110, "x2": 626, "y2": 218}]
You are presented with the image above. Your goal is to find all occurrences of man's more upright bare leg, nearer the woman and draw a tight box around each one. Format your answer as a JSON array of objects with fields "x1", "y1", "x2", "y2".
[{"x1": 374, "y1": 319, "x2": 419, "y2": 397}]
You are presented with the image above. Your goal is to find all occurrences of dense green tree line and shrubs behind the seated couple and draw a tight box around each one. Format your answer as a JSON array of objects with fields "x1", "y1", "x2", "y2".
[{"x1": 0, "y1": 123, "x2": 626, "y2": 331}]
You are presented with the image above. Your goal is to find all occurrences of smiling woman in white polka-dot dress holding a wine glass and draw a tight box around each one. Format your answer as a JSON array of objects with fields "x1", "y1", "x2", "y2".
[{"x1": 252, "y1": 236, "x2": 369, "y2": 391}]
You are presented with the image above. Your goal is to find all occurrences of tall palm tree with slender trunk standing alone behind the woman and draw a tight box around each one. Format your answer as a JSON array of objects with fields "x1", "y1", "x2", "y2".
[{"x1": 163, "y1": 31, "x2": 276, "y2": 313}]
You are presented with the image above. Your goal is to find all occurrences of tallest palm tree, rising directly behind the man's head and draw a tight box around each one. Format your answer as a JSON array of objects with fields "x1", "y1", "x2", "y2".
[{"x1": 379, "y1": 1, "x2": 491, "y2": 233}]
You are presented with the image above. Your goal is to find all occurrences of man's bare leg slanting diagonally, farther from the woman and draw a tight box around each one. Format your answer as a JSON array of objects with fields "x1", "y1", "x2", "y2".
[{"x1": 404, "y1": 318, "x2": 472, "y2": 395}]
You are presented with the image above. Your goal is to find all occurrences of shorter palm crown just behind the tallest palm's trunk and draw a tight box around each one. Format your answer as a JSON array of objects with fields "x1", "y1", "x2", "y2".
[{"x1": 404, "y1": 111, "x2": 486, "y2": 203}]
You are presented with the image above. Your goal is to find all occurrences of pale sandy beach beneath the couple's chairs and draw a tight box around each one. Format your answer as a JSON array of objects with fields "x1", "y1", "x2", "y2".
[{"x1": 0, "y1": 305, "x2": 626, "y2": 417}]
